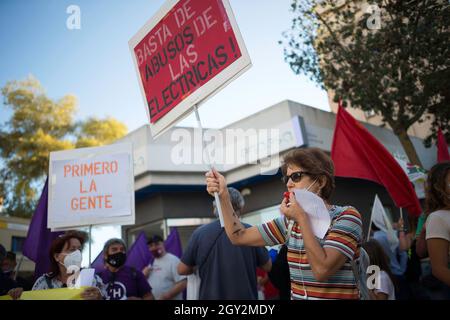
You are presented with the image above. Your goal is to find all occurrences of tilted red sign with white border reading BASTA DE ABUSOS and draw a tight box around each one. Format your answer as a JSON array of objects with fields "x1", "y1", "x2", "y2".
[{"x1": 129, "y1": 0, "x2": 251, "y2": 137}]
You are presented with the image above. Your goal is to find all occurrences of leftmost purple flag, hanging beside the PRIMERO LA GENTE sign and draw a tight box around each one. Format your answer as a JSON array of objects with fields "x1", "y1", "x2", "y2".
[{"x1": 22, "y1": 178, "x2": 63, "y2": 278}]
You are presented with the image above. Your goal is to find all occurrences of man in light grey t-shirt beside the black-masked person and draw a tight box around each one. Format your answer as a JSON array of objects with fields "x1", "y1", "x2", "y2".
[{"x1": 142, "y1": 235, "x2": 187, "y2": 300}]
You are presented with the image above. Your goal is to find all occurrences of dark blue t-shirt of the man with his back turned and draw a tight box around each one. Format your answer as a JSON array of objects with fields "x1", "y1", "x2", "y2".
[{"x1": 181, "y1": 221, "x2": 269, "y2": 300}]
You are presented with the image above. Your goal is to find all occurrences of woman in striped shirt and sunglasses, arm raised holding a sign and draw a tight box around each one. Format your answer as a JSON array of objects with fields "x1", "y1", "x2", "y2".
[{"x1": 206, "y1": 148, "x2": 362, "y2": 299}]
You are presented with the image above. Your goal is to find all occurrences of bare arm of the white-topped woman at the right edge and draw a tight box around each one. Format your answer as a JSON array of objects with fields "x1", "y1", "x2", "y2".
[{"x1": 427, "y1": 238, "x2": 450, "y2": 286}]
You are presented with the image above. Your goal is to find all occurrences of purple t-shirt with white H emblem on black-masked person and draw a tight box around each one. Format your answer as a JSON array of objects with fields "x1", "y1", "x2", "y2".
[{"x1": 98, "y1": 266, "x2": 152, "y2": 300}]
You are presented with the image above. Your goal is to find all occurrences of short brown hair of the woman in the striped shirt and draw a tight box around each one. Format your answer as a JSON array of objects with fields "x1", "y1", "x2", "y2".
[{"x1": 281, "y1": 148, "x2": 336, "y2": 201}]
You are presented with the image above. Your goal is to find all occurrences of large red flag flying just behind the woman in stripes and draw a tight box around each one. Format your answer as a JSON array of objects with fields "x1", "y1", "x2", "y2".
[{"x1": 331, "y1": 103, "x2": 422, "y2": 216}]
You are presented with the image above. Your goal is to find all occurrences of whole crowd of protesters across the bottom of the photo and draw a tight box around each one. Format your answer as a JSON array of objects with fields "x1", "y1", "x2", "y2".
[{"x1": 0, "y1": 148, "x2": 450, "y2": 300}]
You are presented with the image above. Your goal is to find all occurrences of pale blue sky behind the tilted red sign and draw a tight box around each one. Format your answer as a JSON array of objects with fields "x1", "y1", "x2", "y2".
[{"x1": 0, "y1": 0, "x2": 329, "y2": 131}]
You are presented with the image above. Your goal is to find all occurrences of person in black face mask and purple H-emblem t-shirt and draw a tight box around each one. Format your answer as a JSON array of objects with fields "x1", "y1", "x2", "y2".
[{"x1": 99, "y1": 238, "x2": 154, "y2": 300}]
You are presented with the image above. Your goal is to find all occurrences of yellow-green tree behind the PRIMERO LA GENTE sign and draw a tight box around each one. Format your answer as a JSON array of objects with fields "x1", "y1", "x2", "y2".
[{"x1": 0, "y1": 76, "x2": 127, "y2": 217}]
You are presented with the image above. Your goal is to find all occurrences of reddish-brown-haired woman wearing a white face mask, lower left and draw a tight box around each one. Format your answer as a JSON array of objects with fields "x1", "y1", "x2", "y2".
[{"x1": 9, "y1": 231, "x2": 106, "y2": 300}]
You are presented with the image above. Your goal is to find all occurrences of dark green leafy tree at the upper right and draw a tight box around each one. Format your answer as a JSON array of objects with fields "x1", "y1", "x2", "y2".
[{"x1": 281, "y1": 0, "x2": 450, "y2": 165}]
